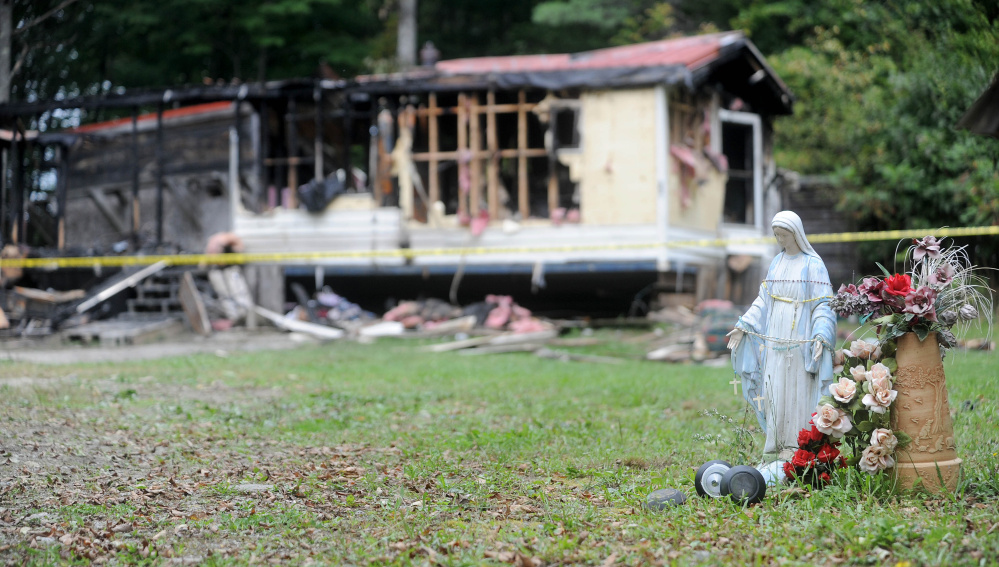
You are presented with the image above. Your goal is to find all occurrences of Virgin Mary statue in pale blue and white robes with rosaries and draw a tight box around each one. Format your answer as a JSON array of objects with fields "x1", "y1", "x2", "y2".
[{"x1": 729, "y1": 211, "x2": 836, "y2": 460}]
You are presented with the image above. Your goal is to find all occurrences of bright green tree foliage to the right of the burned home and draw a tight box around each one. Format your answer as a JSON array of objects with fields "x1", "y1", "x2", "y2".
[{"x1": 734, "y1": 0, "x2": 999, "y2": 268}]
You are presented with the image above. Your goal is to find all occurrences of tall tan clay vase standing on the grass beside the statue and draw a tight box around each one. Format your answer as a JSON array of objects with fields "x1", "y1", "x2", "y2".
[{"x1": 891, "y1": 333, "x2": 961, "y2": 492}]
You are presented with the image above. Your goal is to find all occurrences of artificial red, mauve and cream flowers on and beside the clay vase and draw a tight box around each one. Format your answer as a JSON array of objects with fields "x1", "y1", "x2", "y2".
[{"x1": 784, "y1": 236, "x2": 992, "y2": 486}]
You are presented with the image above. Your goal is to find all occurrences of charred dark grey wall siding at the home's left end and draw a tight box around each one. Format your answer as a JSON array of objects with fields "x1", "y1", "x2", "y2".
[{"x1": 66, "y1": 103, "x2": 256, "y2": 251}]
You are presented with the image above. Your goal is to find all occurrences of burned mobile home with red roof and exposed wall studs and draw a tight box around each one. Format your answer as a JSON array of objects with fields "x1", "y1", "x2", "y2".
[{"x1": 0, "y1": 32, "x2": 792, "y2": 316}]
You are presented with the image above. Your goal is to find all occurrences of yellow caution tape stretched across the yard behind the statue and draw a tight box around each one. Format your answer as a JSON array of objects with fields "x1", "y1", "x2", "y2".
[{"x1": 0, "y1": 226, "x2": 999, "y2": 270}]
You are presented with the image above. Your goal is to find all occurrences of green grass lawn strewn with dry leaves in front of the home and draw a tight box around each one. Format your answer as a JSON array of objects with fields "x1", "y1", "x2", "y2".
[{"x1": 0, "y1": 331, "x2": 999, "y2": 565}]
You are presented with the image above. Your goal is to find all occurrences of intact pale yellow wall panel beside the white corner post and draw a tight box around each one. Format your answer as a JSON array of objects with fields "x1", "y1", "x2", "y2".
[{"x1": 580, "y1": 88, "x2": 657, "y2": 224}]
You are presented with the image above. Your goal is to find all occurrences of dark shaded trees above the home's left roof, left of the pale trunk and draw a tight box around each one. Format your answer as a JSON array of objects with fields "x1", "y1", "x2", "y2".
[{"x1": 5, "y1": 0, "x2": 380, "y2": 100}]
